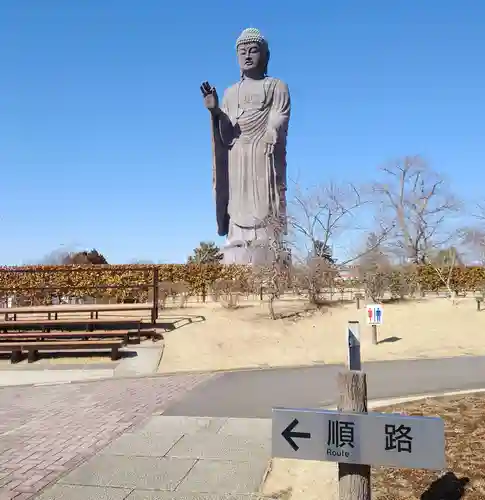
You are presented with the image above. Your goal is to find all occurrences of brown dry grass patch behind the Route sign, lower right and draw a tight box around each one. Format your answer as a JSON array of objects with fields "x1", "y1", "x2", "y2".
[{"x1": 372, "y1": 395, "x2": 485, "y2": 500}]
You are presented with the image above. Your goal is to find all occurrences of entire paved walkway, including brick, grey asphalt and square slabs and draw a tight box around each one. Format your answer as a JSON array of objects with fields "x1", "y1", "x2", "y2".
[{"x1": 0, "y1": 357, "x2": 485, "y2": 500}]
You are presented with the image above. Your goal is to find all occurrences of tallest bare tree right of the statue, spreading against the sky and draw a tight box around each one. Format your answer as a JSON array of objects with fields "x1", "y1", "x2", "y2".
[{"x1": 374, "y1": 156, "x2": 459, "y2": 264}]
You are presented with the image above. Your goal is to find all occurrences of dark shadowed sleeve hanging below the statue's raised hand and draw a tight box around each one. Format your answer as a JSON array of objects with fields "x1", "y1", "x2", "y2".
[{"x1": 211, "y1": 95, "x2": 233, "y2": 236}]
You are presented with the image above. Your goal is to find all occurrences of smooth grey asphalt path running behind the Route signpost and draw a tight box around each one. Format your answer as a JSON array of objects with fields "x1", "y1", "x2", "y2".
[{"x1": 165, "y1": 356, "x2": 485, "y2": 418}]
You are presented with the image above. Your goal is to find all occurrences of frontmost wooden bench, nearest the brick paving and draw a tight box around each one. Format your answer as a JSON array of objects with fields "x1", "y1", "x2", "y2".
[{"x1": 0, "y1": 340, "x2": 123, "y2": 363}]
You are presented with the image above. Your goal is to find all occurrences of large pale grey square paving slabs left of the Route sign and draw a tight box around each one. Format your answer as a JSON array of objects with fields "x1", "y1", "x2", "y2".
[{"x1": 38, "y1": 416, "x2": 271, "y2": 500}]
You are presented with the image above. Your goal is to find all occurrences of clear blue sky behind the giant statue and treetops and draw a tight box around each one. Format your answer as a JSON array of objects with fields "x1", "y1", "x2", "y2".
[{"x1": 0, "y1": 0, "x2": 485, "y2": 265}]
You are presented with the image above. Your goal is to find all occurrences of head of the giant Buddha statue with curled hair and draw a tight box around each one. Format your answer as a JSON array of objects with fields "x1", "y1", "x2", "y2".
[{"x1": 236, "y1": 28, "x2": 269, "y2": 76}]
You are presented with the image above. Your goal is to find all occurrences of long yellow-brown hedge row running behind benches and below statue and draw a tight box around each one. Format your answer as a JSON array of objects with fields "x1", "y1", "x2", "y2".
[{"x1": 0, "y1": 264, "x2": 485, "y2": 300}]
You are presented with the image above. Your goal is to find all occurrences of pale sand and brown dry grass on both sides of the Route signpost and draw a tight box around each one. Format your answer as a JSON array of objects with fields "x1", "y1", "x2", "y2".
[{"x1": 262, "y1": 393, "x2": 485, "y2": 500}]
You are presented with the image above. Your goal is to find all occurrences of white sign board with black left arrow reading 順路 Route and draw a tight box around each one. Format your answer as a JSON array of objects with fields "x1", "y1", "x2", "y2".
[{"x1": 272, "y1": 408, "x2": 446, "y2": 470}]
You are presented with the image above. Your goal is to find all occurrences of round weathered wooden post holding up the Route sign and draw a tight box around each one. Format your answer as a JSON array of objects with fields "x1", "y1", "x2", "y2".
[{"x1": 337, "y1": 371, "x2": 371, "y2": 500}]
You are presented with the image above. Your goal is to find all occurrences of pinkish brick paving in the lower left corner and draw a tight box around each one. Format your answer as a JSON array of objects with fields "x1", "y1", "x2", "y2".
[{"x1": 0, "y1": 374, "x2": 217, "y2": 500}]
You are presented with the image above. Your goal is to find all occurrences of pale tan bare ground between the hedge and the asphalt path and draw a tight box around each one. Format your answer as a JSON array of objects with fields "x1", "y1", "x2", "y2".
[{"x1": 160, "y1": 297, "x2": 485, "y2": 373}]
